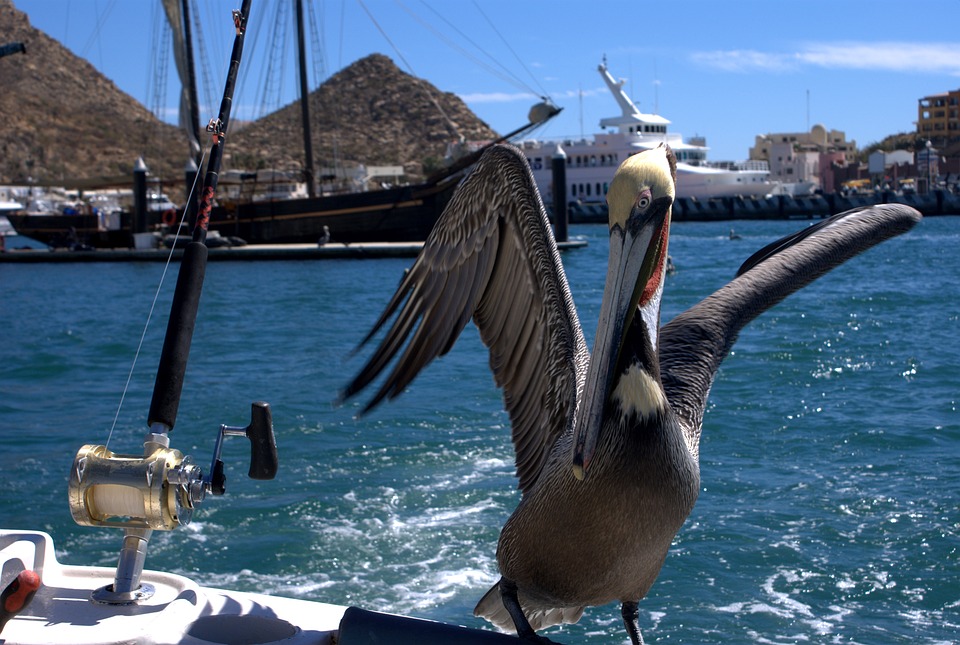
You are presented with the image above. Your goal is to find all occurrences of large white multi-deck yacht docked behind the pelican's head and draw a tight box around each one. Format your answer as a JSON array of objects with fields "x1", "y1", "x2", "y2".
[{"x1": 519, "y1": 60, "x2": 777, "y2": 204}]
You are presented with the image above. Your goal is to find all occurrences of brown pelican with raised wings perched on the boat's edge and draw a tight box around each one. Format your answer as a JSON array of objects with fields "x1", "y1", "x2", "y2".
[{"x1": 342, "y1": 146, "x2": 919, "y2": 644}]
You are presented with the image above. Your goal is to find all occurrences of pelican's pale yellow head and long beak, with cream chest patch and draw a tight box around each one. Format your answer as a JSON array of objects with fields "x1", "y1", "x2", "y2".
[{"x1": 573, "y1": 144, "x2": 677, "y2": 479}]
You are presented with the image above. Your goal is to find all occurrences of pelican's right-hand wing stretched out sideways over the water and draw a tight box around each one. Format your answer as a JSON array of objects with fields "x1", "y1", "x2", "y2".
[{"x1": 659, "y1": 204, "x2": 920, "y2": 449}]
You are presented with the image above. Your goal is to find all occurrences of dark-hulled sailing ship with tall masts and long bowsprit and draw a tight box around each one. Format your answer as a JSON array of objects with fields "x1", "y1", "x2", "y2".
[{"x1": 5, "y1": 0, "x2": 560, "y2": 248}]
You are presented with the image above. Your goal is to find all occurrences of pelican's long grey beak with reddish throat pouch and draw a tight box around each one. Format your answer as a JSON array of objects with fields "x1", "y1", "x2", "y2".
[{"x1": 573, "y1": 146, "x2": 674, "y2": 479}]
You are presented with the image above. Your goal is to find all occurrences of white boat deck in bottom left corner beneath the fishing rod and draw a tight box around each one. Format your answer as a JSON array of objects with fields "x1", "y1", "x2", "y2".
[{"x1": 0, "y1": 530, "x2": 346, "y2": 645}]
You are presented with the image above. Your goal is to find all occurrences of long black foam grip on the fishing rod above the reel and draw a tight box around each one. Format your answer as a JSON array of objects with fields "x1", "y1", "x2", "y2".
[{"x1": 147, "y1": 242, "x2": 207, "y2": 430}]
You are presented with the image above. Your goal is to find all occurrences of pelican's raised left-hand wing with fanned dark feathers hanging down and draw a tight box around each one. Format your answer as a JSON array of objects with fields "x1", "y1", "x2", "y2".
[{"x1": 343, "y1": 146, "x2": 587, "y2": 491}]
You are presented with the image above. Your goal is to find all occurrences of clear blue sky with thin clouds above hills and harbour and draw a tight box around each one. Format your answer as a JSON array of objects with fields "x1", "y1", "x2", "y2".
[{"x1": 14, "y1": 0, "x2": 960, "y2": 160}]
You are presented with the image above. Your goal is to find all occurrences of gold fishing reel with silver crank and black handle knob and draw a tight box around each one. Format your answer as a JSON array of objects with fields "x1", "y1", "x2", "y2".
[{"x1": 68, "y1": 402, "x2": 277, "y2": 531}]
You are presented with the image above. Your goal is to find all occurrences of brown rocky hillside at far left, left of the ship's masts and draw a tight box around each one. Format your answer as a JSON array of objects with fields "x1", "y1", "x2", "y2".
[{"x1": 0, "y1": 0, "x2": 187, "y2": 183}]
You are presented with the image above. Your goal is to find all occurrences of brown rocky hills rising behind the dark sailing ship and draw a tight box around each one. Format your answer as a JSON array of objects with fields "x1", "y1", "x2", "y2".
[{"x1": 0, "y1": 0, "x2": 502, "y2": 193}]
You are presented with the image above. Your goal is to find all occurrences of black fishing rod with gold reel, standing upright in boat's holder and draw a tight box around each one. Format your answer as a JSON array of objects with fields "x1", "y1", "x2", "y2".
[{"x1": 68, "y1": 0, "x2": 277, "y2": 604}]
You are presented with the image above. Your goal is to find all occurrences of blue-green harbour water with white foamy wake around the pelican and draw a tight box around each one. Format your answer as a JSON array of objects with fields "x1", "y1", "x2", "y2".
[{"x1": 0, "y1": 217, "x2": 960, "y2": 644}]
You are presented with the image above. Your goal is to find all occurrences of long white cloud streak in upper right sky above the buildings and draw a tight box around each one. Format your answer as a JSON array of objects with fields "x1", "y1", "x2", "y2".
[{"x1": 690, "y1": 41, "x2": 960, "y2": 76}]
